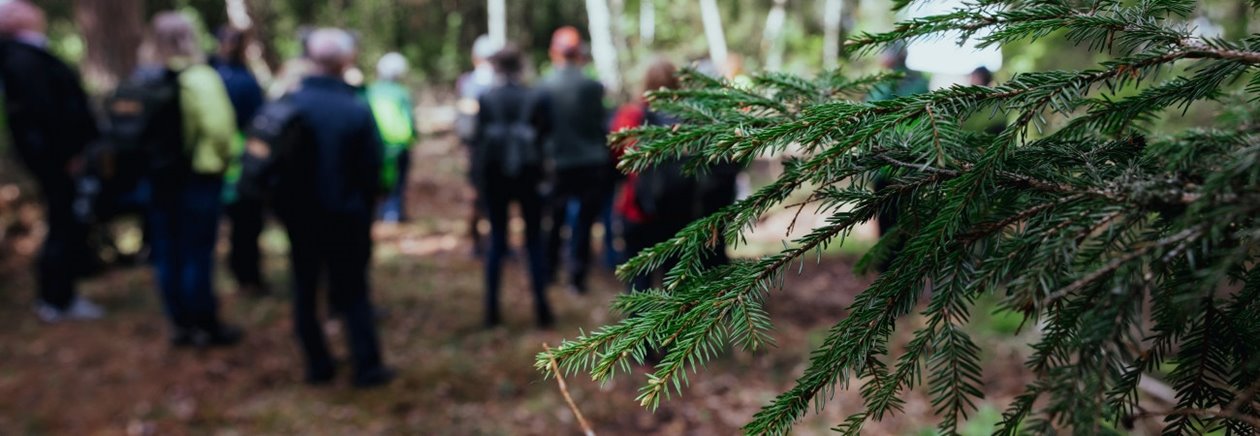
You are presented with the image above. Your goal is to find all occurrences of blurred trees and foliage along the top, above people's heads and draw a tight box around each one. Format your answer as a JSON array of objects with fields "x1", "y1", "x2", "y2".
[{"x1": 17, "y1": 0, "x2": 1255, "y2": 98}]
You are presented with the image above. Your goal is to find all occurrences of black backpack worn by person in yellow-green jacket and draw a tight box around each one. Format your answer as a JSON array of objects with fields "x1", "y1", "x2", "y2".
[{"x1": 101, "y1": 68, "x2": 192, "y2": 194}]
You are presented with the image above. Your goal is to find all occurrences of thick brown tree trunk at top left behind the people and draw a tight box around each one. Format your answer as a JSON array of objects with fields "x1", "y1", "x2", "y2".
[{"x1": 74, "y1": 0, "x2": 145, "y2": 92}]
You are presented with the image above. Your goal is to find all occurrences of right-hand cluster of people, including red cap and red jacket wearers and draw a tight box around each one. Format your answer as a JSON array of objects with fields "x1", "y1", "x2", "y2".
[{"x1": 461, "y1": 26, "x2": 738, "y2": 328}]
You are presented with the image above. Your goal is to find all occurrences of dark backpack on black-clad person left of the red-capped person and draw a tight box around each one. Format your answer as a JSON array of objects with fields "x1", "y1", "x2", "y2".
[{"x1": 478, "y1": 90, "x2": 543, "y2": 178}]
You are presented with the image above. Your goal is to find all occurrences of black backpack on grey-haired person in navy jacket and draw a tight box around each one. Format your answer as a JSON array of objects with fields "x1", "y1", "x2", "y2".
[{"x1": 237, "y1": 97, "x2": 314, "y2": 207}]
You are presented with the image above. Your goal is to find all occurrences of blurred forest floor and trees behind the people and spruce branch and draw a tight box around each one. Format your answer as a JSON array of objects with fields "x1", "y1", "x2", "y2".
[{"x1": 0, "y1": 0, "x2": 1260, "y2": 435}]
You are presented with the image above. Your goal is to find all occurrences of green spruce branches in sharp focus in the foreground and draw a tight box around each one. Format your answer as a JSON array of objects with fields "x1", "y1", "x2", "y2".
[{"x1": 538, "y1": 0, "x2": 1260, "y2": 435}]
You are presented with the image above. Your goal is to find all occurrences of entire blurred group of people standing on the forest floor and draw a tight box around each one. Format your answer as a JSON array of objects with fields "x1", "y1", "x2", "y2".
[{"x1": 0, "y1": 0, "x2": 737, "y2": 387}]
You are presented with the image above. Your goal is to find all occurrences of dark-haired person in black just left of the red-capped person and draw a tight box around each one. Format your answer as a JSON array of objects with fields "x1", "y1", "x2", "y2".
[{"x1": 473, "y1": 47, "x2": 554, "y2": 328}]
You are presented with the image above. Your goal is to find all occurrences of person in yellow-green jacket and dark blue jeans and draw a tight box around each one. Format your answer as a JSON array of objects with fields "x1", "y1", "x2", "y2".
[{"x1": 140, "y1": 11, "x2": 243, "y2": 347}]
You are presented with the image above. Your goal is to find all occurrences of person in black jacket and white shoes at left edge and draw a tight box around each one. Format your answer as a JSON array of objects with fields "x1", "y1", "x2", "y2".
[{"x1": 0, "y1": 0, "x2": 103, "y2": 323}]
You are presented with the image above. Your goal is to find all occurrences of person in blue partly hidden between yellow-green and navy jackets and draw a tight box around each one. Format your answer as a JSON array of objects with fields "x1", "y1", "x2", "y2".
[{"x1": 210, "y1": 28, "x2": 268, "y2": 295}]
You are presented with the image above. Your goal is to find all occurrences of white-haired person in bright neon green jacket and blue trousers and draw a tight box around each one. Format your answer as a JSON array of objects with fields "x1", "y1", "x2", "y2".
[{"x1": 367, "y1": 53, "x2": 417, "y2": 223}]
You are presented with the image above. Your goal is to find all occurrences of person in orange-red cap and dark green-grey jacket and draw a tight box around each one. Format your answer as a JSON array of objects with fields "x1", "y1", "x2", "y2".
[{"x1": 539, "y1": 26, "x2": 615, "y2": 294}]
